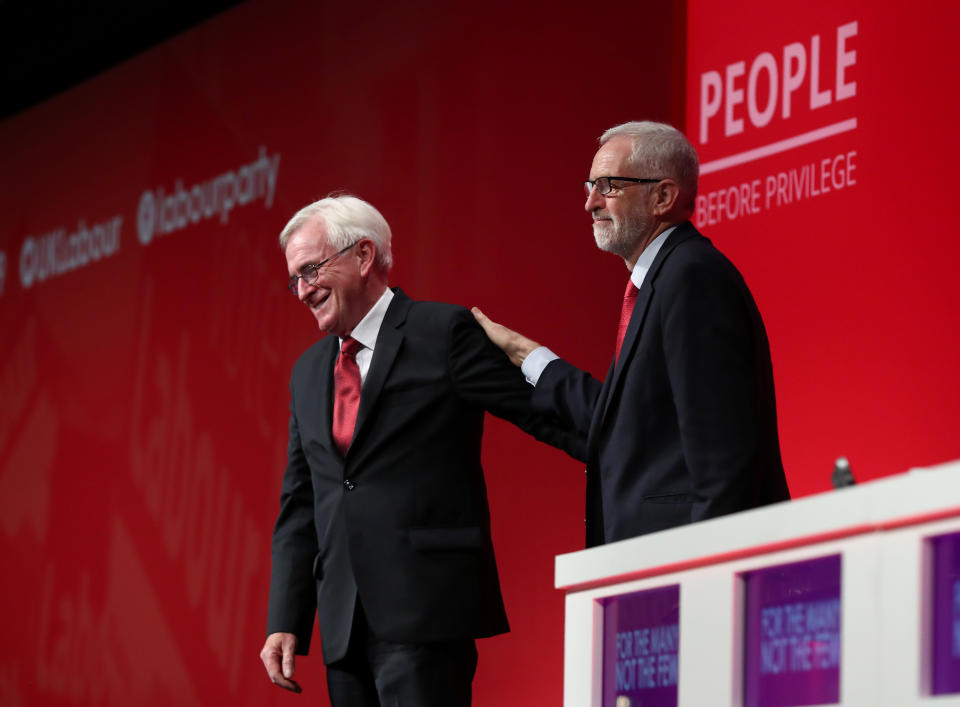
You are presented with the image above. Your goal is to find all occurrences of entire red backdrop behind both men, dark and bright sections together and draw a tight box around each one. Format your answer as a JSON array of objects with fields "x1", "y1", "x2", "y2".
[{"x1": 0, "y1": 0, "x2": 960, "y2": 706}]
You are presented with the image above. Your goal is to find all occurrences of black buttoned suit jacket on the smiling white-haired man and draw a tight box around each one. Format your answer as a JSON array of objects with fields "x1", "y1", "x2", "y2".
[{"x1": 267, "y1": 291, "x2": 583, "y2": 663}]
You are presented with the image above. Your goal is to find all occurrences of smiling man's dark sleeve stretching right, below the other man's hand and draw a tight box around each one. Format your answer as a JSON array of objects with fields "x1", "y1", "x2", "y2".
[{"x1": 448, "y1": 310, "x2": 586, "y2": 461}]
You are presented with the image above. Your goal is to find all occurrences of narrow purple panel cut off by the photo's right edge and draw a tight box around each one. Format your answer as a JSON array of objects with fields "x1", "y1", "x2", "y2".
[{"x1": 930, "y1": 533, "x2": 960, "y2": 695}]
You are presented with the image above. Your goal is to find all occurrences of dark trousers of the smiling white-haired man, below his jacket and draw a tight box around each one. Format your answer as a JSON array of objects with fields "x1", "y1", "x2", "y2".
[{"x1": 327, "y1": 600, "x2": 477, "y2": 707}]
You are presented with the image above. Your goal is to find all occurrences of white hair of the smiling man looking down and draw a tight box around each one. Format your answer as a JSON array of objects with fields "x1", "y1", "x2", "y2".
[{"x1": 280, "y1": 194, "x2": 393, "y2": 271}]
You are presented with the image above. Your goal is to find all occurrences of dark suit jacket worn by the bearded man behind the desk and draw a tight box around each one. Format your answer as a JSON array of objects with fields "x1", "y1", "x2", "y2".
[{"x1": 534, "y1": 222, "x2": 789, "y2": 546}]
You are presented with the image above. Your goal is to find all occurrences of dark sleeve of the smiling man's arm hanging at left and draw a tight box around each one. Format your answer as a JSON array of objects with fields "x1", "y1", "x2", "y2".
[{"x1": 267, "y1": 379, "x2": 318, "y2": 655}]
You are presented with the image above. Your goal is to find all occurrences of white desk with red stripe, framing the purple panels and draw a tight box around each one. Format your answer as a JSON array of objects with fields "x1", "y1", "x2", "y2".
[{"x1": 556, "y1": 461, "x2": 960, "y2": 707}]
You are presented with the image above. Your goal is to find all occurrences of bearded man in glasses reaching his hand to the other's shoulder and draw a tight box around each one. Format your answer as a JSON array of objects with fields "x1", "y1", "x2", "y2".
[{"x1": 474, "y1": 122, "x2": 789, "y2": 547}]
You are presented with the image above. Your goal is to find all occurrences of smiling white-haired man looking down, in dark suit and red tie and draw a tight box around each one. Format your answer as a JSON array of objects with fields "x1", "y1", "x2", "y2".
[{"x1": 260, "y1": 195, "x2": 582, "y2": 707}]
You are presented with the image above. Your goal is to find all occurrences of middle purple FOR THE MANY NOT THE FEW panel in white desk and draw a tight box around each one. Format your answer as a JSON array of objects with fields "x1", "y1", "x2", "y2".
[{"x1": 743, "y1": 555, "x2": 841, "y2": 707}]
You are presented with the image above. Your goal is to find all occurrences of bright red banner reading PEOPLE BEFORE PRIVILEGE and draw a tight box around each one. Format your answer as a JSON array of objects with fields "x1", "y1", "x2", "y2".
[{"x1": 687, "y1": 0, "x2": 960, "y2": 494}]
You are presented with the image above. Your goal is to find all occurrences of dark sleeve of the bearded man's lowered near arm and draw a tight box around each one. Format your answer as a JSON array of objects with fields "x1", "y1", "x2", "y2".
[{"x1": 664, "y1": 261, "x2": 759, "y2": 520}]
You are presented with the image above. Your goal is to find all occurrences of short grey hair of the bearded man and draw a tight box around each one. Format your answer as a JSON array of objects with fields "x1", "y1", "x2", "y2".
[{"x1": 600, "y1": 120, "x2": 700, "y2": 210}]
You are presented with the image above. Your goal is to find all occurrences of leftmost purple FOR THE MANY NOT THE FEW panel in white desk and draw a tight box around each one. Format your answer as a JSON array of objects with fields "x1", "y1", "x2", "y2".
[{"x1": 601, "y1": 584, "x2": 680, "y2": 707}]
